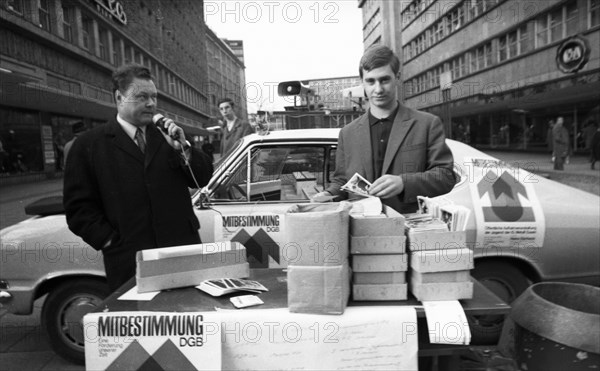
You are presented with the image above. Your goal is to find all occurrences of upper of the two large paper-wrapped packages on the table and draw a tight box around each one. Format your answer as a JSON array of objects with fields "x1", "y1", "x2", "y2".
[{"x1": 285, "y1": 202, "x2": 352, "y2": 266}]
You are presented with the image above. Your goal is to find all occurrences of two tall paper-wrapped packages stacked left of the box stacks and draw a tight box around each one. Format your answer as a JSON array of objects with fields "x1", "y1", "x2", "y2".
[{"x1": 286, "y1": 202, "x2": 352, "y2": 314}]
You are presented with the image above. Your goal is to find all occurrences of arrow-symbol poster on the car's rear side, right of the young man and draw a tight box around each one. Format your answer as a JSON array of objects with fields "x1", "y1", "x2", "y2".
[{"x1": 464, "y1": 158, "x2": 546, "y2": 248}]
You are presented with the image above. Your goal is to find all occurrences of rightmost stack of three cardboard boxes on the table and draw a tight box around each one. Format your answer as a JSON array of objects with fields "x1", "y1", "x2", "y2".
[{"x1": 407, "y1": 228, "x2": 473, "y2": 301}]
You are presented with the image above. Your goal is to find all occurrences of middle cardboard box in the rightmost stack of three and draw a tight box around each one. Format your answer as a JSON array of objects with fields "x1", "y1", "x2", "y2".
[{"x1": 408, "y1": 248, "x2": 474, "y2": 273}]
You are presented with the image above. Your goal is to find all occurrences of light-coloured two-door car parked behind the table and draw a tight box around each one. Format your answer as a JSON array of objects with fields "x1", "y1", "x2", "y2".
[{"x1": 0, "y1": 129, "x2": 600, "y2": 362}]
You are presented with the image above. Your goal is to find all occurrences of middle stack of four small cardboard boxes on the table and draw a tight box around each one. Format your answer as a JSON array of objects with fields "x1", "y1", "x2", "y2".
[{"x1": 350, "y1": 206, "x2": 408, "y2": 301}]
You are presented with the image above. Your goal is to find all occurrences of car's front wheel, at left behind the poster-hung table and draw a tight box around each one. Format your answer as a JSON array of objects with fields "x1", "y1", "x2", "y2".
[{"x1": 42, "y1": 278, "x2": 110, "y2": 364}]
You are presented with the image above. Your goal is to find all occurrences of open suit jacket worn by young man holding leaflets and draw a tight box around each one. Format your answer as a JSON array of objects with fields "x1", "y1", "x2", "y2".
[{"x1": 327, "y1": 105, "x2": 456, "y2": 213}]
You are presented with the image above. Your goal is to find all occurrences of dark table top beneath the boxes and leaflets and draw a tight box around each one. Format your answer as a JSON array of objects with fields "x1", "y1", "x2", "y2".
[{"x1": 97, "y1": 269, "x2": 510, "y2": 369}]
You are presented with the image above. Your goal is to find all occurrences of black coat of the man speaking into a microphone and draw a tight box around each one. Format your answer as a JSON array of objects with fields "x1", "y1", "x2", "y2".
[{"x1": 64, "y1": 118, "x2": 213, "y2": 289}]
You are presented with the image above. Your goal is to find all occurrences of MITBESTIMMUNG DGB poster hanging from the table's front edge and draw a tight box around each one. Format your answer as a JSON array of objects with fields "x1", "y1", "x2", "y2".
[{"x1": 83, "y1": 312, "x2": 221, "y2": 370}]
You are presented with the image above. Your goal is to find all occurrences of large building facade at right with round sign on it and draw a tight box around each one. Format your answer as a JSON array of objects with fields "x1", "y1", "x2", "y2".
[{"x1": 360, "y1": 0, "x2": 600, "y2": 151}]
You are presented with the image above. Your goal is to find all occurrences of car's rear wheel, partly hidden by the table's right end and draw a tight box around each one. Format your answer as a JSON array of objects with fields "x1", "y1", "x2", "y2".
[{"x1": 468, "y1": 261, "x2": 532, "y2": 345}]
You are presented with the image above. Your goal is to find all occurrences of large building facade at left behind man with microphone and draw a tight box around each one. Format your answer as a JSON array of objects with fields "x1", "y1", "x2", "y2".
[{"x1": 0, "y1": 0, "x2": 246, "y2": 183}]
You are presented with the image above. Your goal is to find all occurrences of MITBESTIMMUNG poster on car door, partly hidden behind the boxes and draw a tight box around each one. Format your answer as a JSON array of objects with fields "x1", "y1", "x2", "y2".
[{"x1": 214, "y1": 205, "x2": 290, "y2": 268}]
